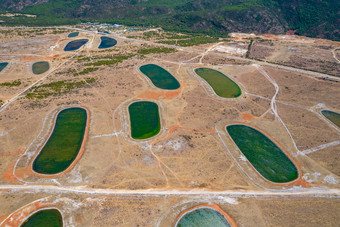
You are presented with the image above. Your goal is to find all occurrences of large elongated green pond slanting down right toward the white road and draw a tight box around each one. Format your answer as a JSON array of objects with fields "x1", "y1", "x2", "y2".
[{"x1": 226, "y1": 124, "x2": 299, "y2": 183}]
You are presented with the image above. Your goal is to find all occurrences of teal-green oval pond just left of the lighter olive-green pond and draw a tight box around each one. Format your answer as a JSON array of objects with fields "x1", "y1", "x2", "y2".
[{"x1": 139, "y1": 64, "x2": 181, "y2": 90}]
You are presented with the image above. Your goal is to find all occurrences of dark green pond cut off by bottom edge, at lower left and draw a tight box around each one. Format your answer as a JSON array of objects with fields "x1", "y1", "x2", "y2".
[{"x1": 21, "y1": 209, "x2": 63, "y2": 227}]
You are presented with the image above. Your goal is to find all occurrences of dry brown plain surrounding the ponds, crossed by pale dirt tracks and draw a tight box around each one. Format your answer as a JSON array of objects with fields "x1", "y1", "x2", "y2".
[{"x1": 0, "y1": 27, "x2": 340, "y2": 226}]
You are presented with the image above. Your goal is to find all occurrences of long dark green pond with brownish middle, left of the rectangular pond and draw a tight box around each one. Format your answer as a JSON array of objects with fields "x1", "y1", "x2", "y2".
[{"x1": 33, "y1": 107, "x2": 87, "y2": 174}]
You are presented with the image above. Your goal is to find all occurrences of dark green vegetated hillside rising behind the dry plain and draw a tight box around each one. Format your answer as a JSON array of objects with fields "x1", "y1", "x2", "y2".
[{"x1": 0, "y1": 0, "x2": 340, "y2": 40}]
